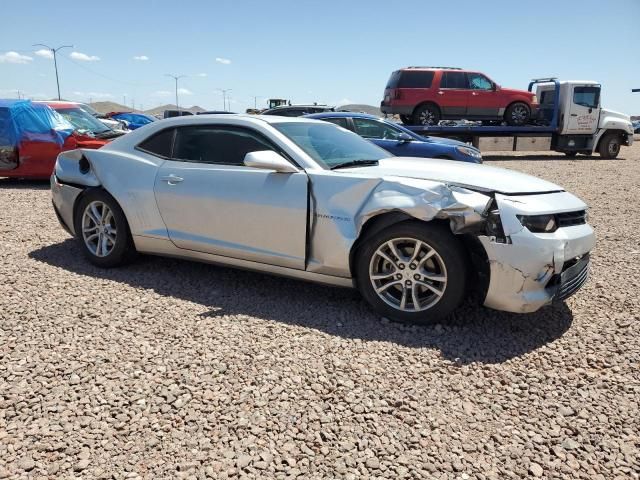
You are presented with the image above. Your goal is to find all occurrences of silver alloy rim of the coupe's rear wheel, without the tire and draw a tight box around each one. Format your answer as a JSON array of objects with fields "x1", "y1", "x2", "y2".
[{"x1": 82, "y1": 200, "x2": 117, "y2": 257}]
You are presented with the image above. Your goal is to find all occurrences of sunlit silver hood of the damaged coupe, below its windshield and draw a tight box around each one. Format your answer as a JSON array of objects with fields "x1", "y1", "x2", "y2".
[{"x1": 342, "y1": 157, "x2": 564, "y2": 194}]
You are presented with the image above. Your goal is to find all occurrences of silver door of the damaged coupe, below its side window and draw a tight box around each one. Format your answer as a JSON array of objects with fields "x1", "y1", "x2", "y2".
[{"x1": 155, "y1": 160, "x2": 307, "y2": 270}]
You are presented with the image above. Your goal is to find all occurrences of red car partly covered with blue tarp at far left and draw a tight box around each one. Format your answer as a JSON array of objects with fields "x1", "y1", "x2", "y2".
[{"x1": 0, "y1": 100, "x2": 110, "y2": 179}]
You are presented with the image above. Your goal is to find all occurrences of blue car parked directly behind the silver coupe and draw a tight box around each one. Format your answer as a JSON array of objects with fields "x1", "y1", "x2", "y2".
[{"x1": 305, "y1": 112, "x2": 482, "y2": 163}]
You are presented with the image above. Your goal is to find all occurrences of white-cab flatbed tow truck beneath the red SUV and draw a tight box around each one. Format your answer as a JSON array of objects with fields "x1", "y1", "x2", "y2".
[{"x1": 405, "y1": 77, "x2": 633, "y2": 159}]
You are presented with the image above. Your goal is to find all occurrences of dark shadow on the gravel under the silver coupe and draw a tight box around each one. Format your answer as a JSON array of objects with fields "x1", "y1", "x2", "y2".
[{"x1": 29, "y1": 239, "x2": 573, "y2": 364}]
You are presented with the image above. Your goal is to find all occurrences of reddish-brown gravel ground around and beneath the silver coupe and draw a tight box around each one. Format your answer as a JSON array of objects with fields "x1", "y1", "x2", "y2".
[{"x1": 0, "y1": 144, "x2": 640, "y2": 480}]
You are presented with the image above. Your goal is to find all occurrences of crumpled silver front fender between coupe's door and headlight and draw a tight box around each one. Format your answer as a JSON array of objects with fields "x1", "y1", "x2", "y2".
[{"x1": 307, "y1": 172, "x2": 493, "y2": 277}]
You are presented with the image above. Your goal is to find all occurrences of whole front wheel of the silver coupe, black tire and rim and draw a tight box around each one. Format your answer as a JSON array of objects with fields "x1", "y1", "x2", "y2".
[{"x1": 356, "y1": 221, "x2": 467, "y2": 324}]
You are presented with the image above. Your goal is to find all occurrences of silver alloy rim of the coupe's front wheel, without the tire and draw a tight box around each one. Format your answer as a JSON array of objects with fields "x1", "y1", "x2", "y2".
[{"x1": 369, "y1": 238, "x2": 447, "y2": 312}]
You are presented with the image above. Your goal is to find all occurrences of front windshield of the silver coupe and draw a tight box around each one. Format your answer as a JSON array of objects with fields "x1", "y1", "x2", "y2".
[{"x1": 272, "y1": 122, "x2": 393, "y2": 168}]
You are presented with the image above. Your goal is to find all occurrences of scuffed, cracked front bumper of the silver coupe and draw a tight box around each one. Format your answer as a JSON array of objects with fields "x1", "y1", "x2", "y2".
[{"x1": 478, "y1": 192, "x2": 595, "y2": 313}]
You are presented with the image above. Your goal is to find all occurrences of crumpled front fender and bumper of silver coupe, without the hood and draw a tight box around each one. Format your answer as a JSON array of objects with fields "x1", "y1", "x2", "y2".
[{"x1": 307, "y1": 173, "x2": 595, "y2": 313}]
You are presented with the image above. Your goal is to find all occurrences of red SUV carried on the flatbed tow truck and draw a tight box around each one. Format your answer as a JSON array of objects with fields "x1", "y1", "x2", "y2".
[{"x1": 380, "y1": 67, "x2": 538, "y2": 126}]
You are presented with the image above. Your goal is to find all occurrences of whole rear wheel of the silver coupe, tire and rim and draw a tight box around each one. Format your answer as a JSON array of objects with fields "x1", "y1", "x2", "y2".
[{"x1": 75, "y1": 189, "x2": 135, "y2": 268}]
